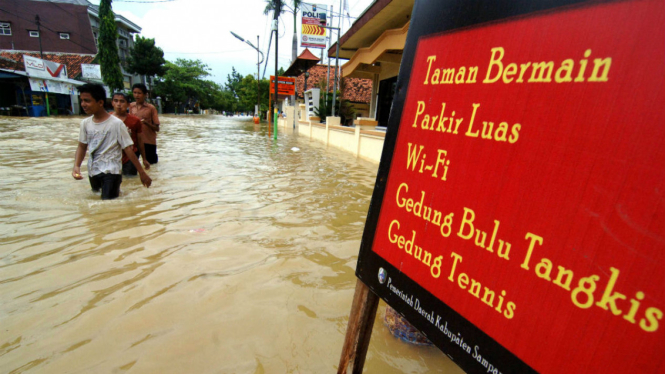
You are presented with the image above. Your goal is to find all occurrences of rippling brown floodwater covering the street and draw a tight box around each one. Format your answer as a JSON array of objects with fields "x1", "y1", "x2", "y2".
[{"x1": 0, "y1": 116, "x2": 461, "y2": 373}]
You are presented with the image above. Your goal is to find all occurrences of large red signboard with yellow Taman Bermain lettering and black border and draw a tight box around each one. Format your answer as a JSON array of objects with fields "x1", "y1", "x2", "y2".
[{"x1": 356, "y1": 0, "x2": 665, "y2": 373}]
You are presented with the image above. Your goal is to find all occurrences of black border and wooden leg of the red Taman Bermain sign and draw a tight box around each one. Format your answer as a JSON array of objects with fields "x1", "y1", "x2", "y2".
[{"x1": 348, "y1": 0, "x2": 660, "y2": 373}]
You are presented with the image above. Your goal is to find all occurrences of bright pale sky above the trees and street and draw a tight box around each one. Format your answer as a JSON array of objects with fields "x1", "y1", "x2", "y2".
[{"x1": 91, "y1": 0, "x2": 372, "y2": 84}]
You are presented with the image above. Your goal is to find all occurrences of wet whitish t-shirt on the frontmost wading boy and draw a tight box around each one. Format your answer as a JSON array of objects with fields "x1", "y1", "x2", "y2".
[{"x1": 79, "y1": 115, "x2": 134, "y2": 177}]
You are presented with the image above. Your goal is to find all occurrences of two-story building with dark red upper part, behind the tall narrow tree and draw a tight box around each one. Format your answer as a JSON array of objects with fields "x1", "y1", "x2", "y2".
[{"x1": 0, "y1": 0, "x2": 142, "y2": 115}]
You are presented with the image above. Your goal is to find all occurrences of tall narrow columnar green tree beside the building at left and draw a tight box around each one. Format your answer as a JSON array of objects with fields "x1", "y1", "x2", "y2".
[{"x1": 98, "y1": 0, "x2": 124, "y2": 91}]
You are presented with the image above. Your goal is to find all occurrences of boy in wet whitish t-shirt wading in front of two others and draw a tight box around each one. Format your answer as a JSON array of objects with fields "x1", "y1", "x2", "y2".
[{"x1": 72, "y1": 83, "x2": 152, "y2": 200}]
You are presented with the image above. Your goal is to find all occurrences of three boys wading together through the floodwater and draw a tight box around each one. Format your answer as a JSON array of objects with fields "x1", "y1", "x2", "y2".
[{"x1": 72, "y1": 83, "x2": 159, "y2": 200}]
